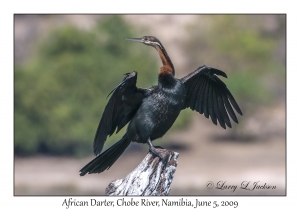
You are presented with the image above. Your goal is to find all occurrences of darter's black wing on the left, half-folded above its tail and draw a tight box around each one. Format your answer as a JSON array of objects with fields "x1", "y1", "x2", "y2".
[{"x1": 94, "y1": 71, "x2": 147, "y2": 155}]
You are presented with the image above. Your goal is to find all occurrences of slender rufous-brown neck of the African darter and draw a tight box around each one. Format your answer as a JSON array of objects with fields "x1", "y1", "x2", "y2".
[{"x1": 154, "y1": 44, "x2": 175, "y2": 76}]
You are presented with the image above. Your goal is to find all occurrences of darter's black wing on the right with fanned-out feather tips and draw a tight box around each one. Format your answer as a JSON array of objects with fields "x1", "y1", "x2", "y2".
[{"x1": 181, "y1": 66, "x2": 243, "y2": 129}]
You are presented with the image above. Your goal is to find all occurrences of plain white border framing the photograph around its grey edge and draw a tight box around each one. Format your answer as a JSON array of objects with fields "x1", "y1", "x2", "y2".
[{"x1": 0, "y1": 0, "x2": 300, "y2": 210}]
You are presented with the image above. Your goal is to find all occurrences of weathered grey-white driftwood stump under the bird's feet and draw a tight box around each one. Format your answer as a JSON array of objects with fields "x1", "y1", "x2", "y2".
[{"x1": 105, "y1": 148, "x2": 179, "y2": 195}]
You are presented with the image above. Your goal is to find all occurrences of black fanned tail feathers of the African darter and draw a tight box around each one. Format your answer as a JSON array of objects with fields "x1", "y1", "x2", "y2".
[{"x1": 80, "y1": 134, "x2": 131, "y2": 176}]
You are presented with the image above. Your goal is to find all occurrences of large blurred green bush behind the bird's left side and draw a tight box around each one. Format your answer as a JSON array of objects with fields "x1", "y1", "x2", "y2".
[{"x1": 14, "y1": 16, "x2": 189, "y2": 156}]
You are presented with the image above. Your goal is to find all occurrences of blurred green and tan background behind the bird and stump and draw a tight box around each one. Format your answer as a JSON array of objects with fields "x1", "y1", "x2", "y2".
[{"x1": 14, "y1": 15, "x2": 286, "y2": 195}]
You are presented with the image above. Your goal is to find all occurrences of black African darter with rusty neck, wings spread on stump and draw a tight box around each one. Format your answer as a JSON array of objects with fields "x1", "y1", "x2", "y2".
[{"x1": 80, "y1": 36, "x2": 243, "y2": 176}]
